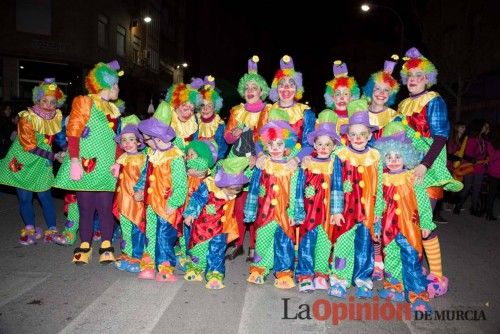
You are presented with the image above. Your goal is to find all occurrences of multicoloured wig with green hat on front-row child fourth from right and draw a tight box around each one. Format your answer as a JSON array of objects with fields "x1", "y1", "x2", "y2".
[{"x1": 259, "y1": 109, "x2": 297, "y2": 150}]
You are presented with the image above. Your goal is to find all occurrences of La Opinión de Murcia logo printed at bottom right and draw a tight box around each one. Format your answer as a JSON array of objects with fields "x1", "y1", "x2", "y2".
[{"x1": 281, "y1": 296, "x2": 486, "y2": 325}]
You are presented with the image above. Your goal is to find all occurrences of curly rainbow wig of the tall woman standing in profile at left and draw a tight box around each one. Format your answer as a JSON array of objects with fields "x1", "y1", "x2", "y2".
[{"x1": 85, "y1": 60, "x2": 124, "y2": 94}]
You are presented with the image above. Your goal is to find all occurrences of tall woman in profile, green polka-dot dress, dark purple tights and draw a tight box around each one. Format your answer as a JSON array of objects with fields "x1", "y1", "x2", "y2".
[{"x1": 54, "y1": 60, "x2": 123, "y2": 264}]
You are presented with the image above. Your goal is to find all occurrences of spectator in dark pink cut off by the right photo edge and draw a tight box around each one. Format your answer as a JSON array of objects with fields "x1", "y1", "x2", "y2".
[{"x1": 486, "y1": 124, "x2": 500, "y2": 220}]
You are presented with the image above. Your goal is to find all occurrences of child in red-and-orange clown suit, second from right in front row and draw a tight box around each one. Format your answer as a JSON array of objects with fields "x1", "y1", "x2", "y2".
[{"x1": 328, "y1": 99, "x2": 383, "y2": 298}]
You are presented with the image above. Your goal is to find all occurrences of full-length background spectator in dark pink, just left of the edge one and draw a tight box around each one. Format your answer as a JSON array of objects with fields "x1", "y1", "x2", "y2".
[{"x1": 453, "y1": 120, "x2": 490, "y2": 217}]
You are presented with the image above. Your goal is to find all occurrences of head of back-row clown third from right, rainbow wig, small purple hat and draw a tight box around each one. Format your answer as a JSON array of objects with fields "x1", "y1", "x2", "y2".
[{"x1": 323, "y1": 60, "x2": 359, "y2": 138}]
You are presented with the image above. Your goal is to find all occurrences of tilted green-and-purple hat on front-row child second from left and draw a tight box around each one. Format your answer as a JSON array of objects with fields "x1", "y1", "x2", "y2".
[{"x1": 139, "y1": 101, "x2": 175, "y2": 143}]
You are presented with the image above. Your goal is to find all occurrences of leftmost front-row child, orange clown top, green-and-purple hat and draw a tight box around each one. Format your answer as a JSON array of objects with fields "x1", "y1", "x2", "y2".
[{"x1": 113, "y1": 115, "x2": 146, "y2": 273}]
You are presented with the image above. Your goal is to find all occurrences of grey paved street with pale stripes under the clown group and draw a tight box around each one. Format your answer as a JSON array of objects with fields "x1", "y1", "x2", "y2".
[{"x1": 0, "y1": 190, "x2": 500, "y2": 333}]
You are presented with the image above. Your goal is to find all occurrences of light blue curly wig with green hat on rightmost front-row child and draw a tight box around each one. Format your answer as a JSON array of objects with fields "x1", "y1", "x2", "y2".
[{"x1": 375, "y1": 121, "x2": 422, "y2": 169}]
